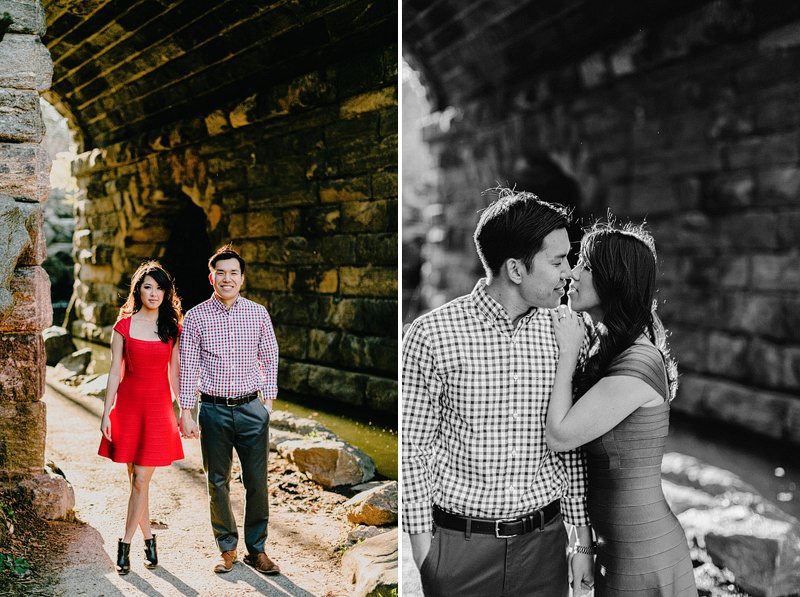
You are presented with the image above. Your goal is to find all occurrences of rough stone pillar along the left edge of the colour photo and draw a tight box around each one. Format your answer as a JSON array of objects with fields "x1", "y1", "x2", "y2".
[{"x1": 0, "y1": 1, "x2": 53, "y2": 474}]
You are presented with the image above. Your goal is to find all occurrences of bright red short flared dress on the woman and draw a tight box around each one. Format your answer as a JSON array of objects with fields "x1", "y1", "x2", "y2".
[{"x1": 97, "y1": 318, "x2": 183, "y2": 466}]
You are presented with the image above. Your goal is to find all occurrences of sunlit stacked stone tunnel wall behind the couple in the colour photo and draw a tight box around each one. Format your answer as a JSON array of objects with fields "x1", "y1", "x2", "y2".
[{"x1": 72, "y1": 44, "x2": 398, "y2": 412}]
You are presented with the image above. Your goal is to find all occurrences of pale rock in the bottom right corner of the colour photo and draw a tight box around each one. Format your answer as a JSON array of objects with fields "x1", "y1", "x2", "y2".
[{"x1": 342, "y1": 529, "x2": 398, "y2": 597}]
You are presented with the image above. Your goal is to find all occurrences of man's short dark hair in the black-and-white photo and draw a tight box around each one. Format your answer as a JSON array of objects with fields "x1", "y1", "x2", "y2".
[{"x1": 474, "y1": 187, "x2": 571, "y2": 276}]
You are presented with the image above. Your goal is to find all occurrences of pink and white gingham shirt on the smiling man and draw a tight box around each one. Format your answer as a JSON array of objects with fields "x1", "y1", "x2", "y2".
[{"x1": 180, "y1": 295, "x2": 278, "y2": 409}]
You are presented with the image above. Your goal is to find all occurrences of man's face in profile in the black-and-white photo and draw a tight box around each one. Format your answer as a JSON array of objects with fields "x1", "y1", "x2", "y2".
[{"x1": 520, "y1": 228, "x2": 570, "y2": 309}]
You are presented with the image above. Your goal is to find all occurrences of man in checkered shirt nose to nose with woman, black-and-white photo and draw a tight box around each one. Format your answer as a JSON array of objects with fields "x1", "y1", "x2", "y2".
[{"x1": 402, "y1": 189, "x2": 593, "y2": 597}]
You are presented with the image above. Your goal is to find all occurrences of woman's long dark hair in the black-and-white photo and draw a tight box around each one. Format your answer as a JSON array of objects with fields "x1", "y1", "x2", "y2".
[{"x1": 575, "y1": 221, "x2": 678, "y2": 400}]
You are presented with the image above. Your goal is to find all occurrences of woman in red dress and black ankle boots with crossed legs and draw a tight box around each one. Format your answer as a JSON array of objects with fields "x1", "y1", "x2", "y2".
[{"x1": 98, "y1": 261, "x2": 183, "y2": 574}]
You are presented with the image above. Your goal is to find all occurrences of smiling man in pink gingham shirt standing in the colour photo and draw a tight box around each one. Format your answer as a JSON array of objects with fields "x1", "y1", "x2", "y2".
[{"x1": 180, "y1": 245, "x2": 280, "y2": 574}]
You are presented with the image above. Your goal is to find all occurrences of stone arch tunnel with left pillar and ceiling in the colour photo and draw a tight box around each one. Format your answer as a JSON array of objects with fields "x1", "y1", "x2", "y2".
[{"x1": 0, "y1": 0, "x2": 398, "y2": 496}]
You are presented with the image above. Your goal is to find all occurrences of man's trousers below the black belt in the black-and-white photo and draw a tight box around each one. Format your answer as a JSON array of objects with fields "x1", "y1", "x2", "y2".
[{"x1": 420, "y1": 515, "x2": 569, "y2": 597}]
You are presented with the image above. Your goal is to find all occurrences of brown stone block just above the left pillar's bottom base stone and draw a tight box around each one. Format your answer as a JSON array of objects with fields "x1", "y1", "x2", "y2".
[{"x1": 0, "y1": 400, "x2": 47, "y2": 479}]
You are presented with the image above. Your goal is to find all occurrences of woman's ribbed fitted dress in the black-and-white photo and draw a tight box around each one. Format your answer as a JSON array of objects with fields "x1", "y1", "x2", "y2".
[{"x1": 585, "y1": 343, "x2": 697, "y2": 597}]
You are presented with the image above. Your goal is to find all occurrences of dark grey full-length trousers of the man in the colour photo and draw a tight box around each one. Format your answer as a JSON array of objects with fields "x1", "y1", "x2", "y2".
[{"x1": 198, "y1": 399, "x2": 269, "y2": 554}]
